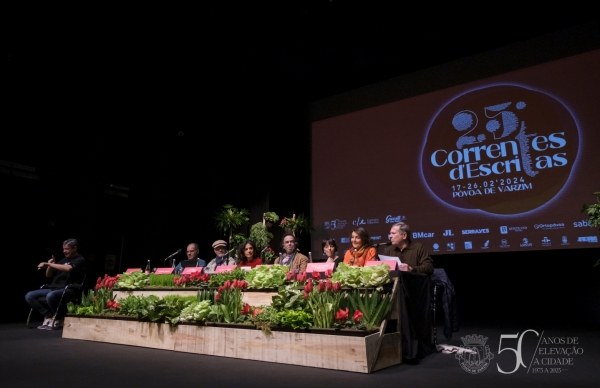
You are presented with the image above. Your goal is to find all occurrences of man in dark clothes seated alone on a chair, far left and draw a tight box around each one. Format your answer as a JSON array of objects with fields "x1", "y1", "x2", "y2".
[{"x1": 25, "y1": 238, "x2": 85, "y2": 330}]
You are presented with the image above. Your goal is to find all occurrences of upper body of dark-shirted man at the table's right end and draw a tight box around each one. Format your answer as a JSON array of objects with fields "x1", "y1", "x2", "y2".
[{"x1": 383, "y1": 222, "x2": 433, "y2": 275}]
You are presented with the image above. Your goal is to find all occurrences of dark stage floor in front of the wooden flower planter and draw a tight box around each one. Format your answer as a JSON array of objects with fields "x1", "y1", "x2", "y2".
[{"x1": 0, "y1": 324, "x2": 600, "y2": 388}]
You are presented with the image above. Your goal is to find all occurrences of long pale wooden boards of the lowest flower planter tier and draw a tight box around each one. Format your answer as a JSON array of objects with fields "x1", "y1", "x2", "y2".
[{"x1": 63, "y1": 316, "x2": 402, "y2": 373}]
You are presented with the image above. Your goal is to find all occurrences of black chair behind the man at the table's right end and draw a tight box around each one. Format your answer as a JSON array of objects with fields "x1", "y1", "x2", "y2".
[{"x1": 431, "y1": 268, "x2": 459, "y2": 346}]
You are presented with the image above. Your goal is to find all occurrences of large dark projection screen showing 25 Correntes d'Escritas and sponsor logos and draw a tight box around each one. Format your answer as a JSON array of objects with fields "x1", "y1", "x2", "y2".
[{"x1": 312, "y1": 50, "x2": 600, "y2": 257}]
